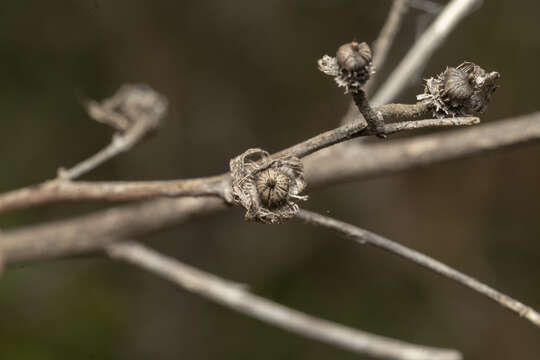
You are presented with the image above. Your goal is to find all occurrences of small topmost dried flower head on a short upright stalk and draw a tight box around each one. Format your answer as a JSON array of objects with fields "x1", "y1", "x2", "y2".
[{"x1": 318, "y1": 41, "x2": 375, "y2": 93}]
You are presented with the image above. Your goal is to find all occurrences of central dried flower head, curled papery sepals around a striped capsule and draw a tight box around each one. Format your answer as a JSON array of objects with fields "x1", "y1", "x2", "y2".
[{"x1": 230, "y1": 149, "x2": 307, "y2": 224}]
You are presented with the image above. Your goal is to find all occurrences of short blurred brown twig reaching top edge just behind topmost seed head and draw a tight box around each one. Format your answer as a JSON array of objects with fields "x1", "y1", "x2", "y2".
[{"x1": 364, "y1": 0, "x2": 408, "y2": 94}]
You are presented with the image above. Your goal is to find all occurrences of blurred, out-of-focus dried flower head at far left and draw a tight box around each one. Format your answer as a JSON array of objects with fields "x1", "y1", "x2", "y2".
[{"x1": 86, "y1": 84, "x2": 167, "y2": 133}]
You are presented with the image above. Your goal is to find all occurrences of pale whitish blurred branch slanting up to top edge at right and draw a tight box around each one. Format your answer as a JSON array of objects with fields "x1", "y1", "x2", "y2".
[{"x1": 372, "y1": 0, "x2": 481, "y2": 106}]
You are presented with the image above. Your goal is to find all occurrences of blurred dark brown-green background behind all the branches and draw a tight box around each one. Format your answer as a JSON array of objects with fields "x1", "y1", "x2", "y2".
[{"x1": 0, "y1": 0, "x2": 540, "y2": 360}]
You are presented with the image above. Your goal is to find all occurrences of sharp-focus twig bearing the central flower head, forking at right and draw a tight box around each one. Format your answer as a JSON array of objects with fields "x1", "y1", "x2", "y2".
[{"x1": 0, "y1": 100, "x2": 472, "y2": 213}]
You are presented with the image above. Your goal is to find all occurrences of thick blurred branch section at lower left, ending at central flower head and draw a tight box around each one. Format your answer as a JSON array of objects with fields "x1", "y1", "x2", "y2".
[{"x1": 0, "y1": 197, "x2": 229, "y2": 264}]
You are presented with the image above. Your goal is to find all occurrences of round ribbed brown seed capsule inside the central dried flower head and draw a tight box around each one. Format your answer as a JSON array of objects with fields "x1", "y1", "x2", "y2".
[{"x1": 256, "y1": 168, "x2": 289, "y2": 209}]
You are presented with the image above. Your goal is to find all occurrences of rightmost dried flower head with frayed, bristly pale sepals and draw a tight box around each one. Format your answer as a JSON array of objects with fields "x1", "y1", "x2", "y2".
[{"x1": 416, "y1": 62, "x2": 500, "y2": 118}]
